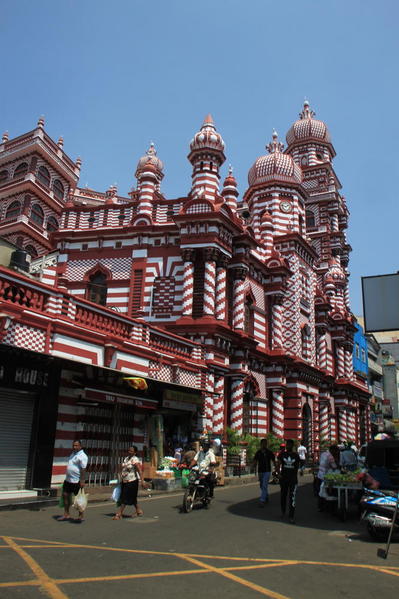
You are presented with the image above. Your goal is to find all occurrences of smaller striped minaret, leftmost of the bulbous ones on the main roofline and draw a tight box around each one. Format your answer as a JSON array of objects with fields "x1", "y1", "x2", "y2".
[{"x1": 135, "y1": 142, "x2": 164, "y2": 216}]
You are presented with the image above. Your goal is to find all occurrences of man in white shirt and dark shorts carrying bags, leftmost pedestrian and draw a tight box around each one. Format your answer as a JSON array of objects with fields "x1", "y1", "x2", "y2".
[{"x1": 58, "y1": 441, "x2": 89, "y2": 522}]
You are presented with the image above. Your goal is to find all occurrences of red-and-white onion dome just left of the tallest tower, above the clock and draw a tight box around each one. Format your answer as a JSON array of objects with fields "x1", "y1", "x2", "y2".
[{"x1": 248, "y1": 131, "x2": 302, "y2": 186}]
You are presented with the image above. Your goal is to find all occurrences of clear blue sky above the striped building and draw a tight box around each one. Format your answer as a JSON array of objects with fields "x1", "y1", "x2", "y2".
[{"x1": 0, "y1": 0, "x2": 399, "y2": 313}]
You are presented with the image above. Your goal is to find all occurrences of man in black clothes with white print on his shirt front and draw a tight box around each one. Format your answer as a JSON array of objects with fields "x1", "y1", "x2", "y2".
[{"x1": 278, "y1": 439, "x2": 299, "y2": 524}]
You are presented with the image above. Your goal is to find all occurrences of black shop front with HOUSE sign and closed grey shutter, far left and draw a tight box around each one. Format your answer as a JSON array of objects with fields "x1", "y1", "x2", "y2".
[{"x1": 0, "y1": 346, "x2": 60, "y2": 491}]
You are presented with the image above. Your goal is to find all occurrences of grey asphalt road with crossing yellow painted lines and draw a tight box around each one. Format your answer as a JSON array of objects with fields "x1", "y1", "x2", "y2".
[{"x1": 0, "y1": 476, "x2": 399, "y2": 599}]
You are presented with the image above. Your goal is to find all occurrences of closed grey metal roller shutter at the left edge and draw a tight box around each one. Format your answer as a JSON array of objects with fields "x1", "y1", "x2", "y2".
[{"x1": 0, "y1": 390, "x2": 35, "y2": 491}]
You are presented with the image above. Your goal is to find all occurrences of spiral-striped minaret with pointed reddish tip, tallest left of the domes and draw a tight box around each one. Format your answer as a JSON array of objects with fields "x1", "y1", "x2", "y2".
[{"x1": 188, "y1": 114, "x2": 226, "y2": 200}]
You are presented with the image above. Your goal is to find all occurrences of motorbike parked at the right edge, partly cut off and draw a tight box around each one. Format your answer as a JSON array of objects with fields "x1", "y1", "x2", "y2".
[{"x1": 360, "y1": 489, "x2": 399, "y2": 539}]
